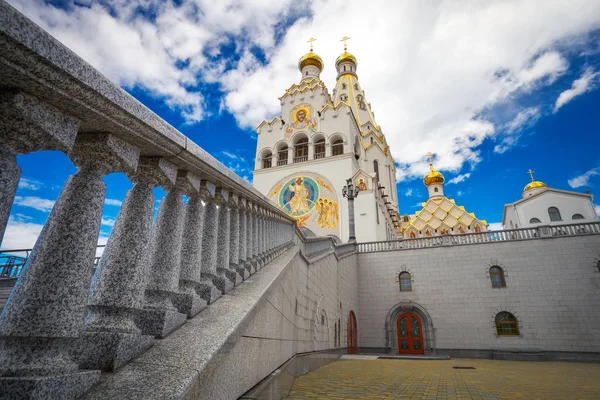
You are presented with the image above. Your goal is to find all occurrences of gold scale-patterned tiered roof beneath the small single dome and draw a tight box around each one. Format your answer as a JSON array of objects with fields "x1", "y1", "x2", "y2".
[{"x1": 401, "y1": 196, "x2": 488, "y2": 238}]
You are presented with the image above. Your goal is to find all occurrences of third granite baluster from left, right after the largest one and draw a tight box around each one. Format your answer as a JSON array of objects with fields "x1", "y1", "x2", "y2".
[{"x1": 80, "y1": 157, "x2": 177, "y2": 371}]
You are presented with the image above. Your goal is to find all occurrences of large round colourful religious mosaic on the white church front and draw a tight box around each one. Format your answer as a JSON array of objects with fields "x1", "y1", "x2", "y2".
[{"x1": 269, "y1": 173, "x2": 340, "y2": 233}]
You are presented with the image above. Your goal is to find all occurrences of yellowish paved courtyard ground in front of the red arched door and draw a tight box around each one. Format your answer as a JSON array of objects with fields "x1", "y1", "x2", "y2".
[{"x1": 288, "y1": 359, "x2": 600, "y2": 400}]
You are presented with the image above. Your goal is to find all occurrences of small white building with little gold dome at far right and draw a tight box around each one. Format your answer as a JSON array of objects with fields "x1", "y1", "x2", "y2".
[{"x1": 502, "y1": 170, "x2": 598, "y2": 229}]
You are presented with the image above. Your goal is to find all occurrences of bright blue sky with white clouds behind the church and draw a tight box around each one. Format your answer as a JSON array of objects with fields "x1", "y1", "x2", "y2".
[{"x1": 2, "y1": 0, "x2": 600, "y2": 248}]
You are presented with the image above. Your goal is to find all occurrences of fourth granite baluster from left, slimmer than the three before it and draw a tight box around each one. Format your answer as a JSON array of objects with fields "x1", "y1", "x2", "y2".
[{"x1": 137, "y1": 170, "x2": 200, "y2": 338}]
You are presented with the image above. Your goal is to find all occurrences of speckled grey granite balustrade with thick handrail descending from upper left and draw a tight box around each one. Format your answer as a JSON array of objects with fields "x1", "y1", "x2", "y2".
[{"x1": 0, "y1": 0, "x2": 295, "y2": 398}]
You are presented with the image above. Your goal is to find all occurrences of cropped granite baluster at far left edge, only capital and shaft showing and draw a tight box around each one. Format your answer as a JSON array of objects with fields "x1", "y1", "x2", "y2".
[{"x1": 0, "y1": 91, "x2": 79, "y2": 244}]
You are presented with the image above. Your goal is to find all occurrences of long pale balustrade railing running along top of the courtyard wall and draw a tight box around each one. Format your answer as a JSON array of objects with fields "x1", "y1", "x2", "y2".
[{"x1": 357, "y1": 222, "x2": 600, "y2": 253}]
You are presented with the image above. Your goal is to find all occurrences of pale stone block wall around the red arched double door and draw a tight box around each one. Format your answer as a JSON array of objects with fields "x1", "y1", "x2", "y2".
[{"x1": 358, "y1": 235, "x2": 600, "y2": 352}]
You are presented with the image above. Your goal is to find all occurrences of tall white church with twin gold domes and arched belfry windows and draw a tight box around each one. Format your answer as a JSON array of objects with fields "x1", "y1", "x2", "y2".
[{"x1": 253, "y1": 44, "x2": 399, "y2": 242}]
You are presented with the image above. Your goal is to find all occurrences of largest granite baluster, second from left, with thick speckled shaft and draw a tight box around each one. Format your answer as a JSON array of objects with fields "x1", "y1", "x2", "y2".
[{"x1": 0, "y1": 134, "x2": 139, "y2": 398}]
